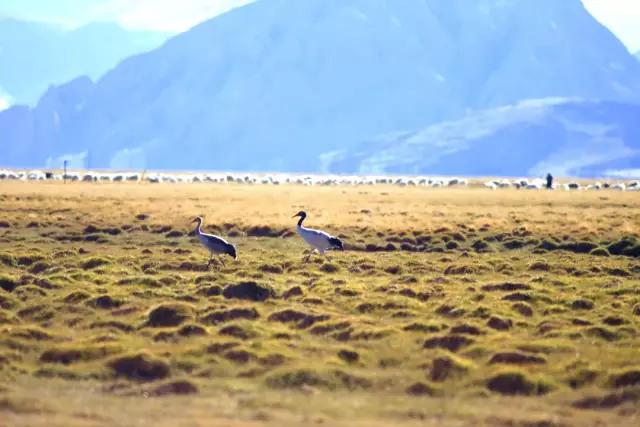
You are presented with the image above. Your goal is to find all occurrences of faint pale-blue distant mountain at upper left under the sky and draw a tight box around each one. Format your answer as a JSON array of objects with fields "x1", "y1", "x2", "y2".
[{"x1": 0, "y1": 19, "x2": 168, "y2": 105}]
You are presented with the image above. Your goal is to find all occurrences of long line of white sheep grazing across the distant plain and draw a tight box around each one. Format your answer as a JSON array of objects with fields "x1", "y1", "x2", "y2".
[{"x1": 0, "y1": 169, "x2": 640, "y2": 191}]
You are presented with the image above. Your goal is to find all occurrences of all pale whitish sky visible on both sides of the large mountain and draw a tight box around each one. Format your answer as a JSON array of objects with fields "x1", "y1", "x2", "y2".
[{"x1": 0, "y1": 0, "x2": 640, "y2": 52}]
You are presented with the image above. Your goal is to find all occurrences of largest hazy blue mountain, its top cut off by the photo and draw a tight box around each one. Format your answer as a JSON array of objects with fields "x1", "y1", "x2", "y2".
[{"x1": 0, "y1": 0, "x2": 640, "y2": 171}]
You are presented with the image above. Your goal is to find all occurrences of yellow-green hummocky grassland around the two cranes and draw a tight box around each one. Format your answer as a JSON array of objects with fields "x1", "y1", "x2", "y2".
[{"x1": 0, "y1": 182, "x2": 640, "y2": 426}]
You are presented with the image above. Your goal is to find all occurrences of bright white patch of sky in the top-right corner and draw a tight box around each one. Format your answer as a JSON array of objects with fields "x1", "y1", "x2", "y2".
[{"x1": 584, "y1": 0, "x2": 640, "y2": 52}]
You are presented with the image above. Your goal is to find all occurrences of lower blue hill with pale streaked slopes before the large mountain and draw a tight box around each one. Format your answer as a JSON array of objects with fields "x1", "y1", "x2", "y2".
[{"x1": 330, "y1": 98, "x2": 640, "y2": 177}]
